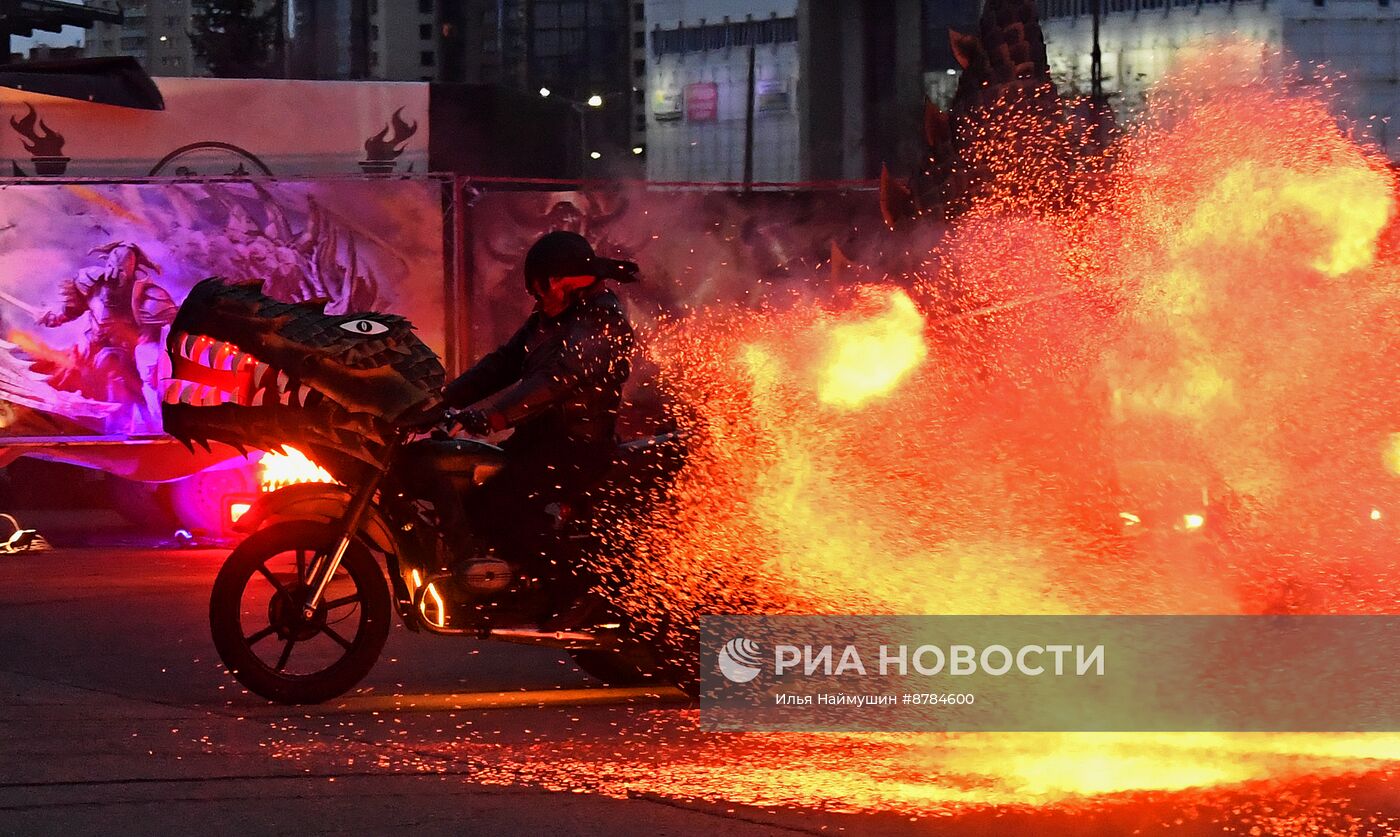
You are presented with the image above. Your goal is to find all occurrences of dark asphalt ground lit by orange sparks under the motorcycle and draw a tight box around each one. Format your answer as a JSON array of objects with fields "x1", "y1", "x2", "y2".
[{"x1": 0, "y1": 549, "x2": 1400, "y2": 837}]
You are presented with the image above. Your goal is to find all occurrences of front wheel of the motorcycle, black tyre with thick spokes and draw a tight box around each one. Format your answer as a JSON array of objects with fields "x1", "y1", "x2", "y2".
[{"x1": 209, "y1": 522, "x2": 391, "y2": 704}]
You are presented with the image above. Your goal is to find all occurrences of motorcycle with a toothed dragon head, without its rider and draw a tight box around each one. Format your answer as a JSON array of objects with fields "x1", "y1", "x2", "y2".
[{"x1": 161, "y1": 279, "x2": 697, "y2": 704}]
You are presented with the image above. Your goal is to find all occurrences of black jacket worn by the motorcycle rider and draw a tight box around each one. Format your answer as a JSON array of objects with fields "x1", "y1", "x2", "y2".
[{"x1": 442, "y1": 284, "x2": 634, "y2": 456}]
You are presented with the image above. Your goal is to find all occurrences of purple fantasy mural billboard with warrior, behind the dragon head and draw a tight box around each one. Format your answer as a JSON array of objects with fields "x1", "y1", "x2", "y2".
[{"x1": 0, "y1": 178, "x2": 447, "y2": 445}]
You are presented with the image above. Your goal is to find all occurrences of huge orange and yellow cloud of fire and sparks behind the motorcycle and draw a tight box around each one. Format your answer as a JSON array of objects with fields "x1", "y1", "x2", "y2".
[{"x1": 579, "y1": 42, "x2": 1400, "y2": 808}]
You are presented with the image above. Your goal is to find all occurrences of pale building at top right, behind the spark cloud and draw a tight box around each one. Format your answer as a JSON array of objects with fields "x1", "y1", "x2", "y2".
[{"x1": 1039, "y1": 0, "x2": 1400, "y2": 158}]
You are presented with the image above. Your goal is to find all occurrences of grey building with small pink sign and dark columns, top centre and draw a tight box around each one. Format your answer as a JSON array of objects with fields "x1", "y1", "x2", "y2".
[{"x1": 647, "y1": 0, "x2": 948, "y2": 182}]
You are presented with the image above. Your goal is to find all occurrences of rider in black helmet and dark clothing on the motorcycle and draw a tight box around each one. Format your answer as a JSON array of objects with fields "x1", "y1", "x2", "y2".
[{"x1": 442, "y1": 231, "x2": 637, "y2": 557}]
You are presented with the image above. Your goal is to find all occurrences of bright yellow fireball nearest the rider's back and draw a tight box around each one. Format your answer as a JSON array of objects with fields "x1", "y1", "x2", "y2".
[{"x1": 818, "y1": 290, "x2": 928, "y2": 409}]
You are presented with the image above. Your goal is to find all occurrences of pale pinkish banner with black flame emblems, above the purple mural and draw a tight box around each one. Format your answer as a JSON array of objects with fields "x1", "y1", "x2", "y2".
[{"x1": 0, "y1": 78, "x2": 428, "y2": 178}]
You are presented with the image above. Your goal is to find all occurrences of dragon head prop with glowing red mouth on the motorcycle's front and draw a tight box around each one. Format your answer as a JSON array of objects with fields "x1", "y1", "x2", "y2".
[{"x1": 161, "y1": 279, "x2": 445, "y2": 479}]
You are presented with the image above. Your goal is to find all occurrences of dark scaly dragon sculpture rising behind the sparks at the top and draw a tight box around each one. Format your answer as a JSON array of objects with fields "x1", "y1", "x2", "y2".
[{"x1": 881, "y1": 0, "x2": 1113, "y2": 230}]
